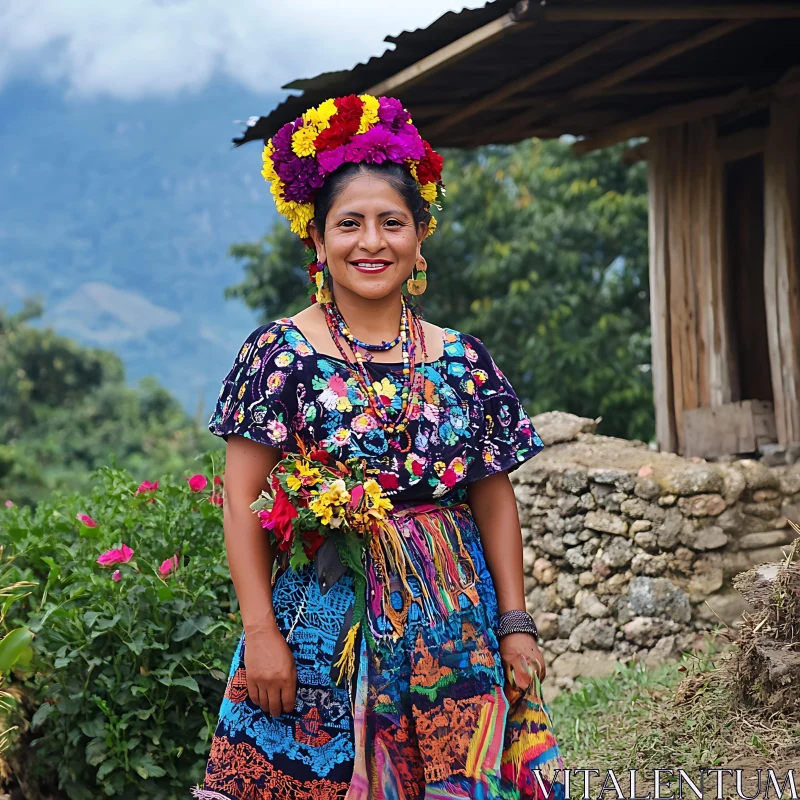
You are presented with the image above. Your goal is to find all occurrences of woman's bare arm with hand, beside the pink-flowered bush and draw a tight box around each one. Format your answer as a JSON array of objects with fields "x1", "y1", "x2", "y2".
[{"x1": 223, "y1": 434, "x2": 297, "y2": 716}]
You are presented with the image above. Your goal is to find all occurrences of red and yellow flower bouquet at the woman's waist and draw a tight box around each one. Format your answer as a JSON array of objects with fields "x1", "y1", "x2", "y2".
[{"x1": 251, "y1": 437, "x2": 392, "y2": 675}]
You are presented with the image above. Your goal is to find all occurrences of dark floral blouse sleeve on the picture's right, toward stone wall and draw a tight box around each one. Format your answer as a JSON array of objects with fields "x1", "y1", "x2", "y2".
[{"x1": 467, "y1": 337, "x2": 544, "y2": 481}]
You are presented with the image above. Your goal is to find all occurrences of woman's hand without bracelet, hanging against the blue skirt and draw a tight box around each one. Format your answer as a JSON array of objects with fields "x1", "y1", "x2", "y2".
[{"x1": 244, "y1": 627, "x2": 297, "y2": 717}]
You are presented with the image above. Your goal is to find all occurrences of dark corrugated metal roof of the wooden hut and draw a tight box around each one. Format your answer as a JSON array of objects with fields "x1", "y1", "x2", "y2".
[{"x1": 235, "y1": 0, "x2": 800, "y2": 147}]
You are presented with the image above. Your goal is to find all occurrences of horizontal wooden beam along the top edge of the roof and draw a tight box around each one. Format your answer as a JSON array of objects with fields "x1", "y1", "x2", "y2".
[{"x1": 528, "y1": 3, "x2": 800, "y2": 22}]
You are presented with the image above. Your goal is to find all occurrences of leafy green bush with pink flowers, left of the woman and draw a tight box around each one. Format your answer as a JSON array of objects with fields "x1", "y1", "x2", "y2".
[{"x1": 0, "y1": 456, "x2": 240, "y2": 800}]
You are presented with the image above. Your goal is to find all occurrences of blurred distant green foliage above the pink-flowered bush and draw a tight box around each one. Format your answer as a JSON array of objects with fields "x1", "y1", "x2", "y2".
[{"x1": 0, "y1": 305, "x2": 212, "y2": 503}]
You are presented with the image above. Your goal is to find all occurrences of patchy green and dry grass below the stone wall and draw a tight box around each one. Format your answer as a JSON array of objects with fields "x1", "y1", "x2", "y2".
[{"x1": 550, "y1": 642, "x2": 800, "y2": 770}]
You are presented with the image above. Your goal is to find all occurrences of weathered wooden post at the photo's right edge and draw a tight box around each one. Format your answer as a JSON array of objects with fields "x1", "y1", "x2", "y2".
[{"x1": 764, "y1": 98, "x2": 800, "y2": 444}]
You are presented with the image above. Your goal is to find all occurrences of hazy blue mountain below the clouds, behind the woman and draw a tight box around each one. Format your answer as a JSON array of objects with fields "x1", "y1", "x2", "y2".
[{"x1": 0, "y1": 82, "x2": 280, "y2": 415}]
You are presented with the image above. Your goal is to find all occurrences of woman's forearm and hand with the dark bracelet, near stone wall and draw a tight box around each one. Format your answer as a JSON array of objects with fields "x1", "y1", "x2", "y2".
[{"x1": 467, "y1": 472, "x2": 546, "y2": 689}]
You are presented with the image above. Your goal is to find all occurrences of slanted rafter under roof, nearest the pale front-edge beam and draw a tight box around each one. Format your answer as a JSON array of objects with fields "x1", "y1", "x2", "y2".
[{"x1": 425, "y1": 22, "x2": 651, "y2": 138}]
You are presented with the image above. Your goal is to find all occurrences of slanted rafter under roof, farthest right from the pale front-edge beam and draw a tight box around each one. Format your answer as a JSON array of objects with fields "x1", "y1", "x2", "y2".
[{"x1": 488, "y1": 20, "x2": 749, "y2": 142}]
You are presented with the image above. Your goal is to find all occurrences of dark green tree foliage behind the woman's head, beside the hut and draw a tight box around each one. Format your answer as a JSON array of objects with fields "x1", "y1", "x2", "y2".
[{"x1": 223, "y1": 140, "x2": 654, "y2": 439}]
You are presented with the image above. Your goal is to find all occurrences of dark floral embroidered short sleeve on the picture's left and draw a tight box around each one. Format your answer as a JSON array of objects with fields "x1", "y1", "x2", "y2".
[{"x1": 208, "y1": 323, "x2": 299, "y2": 448}]
